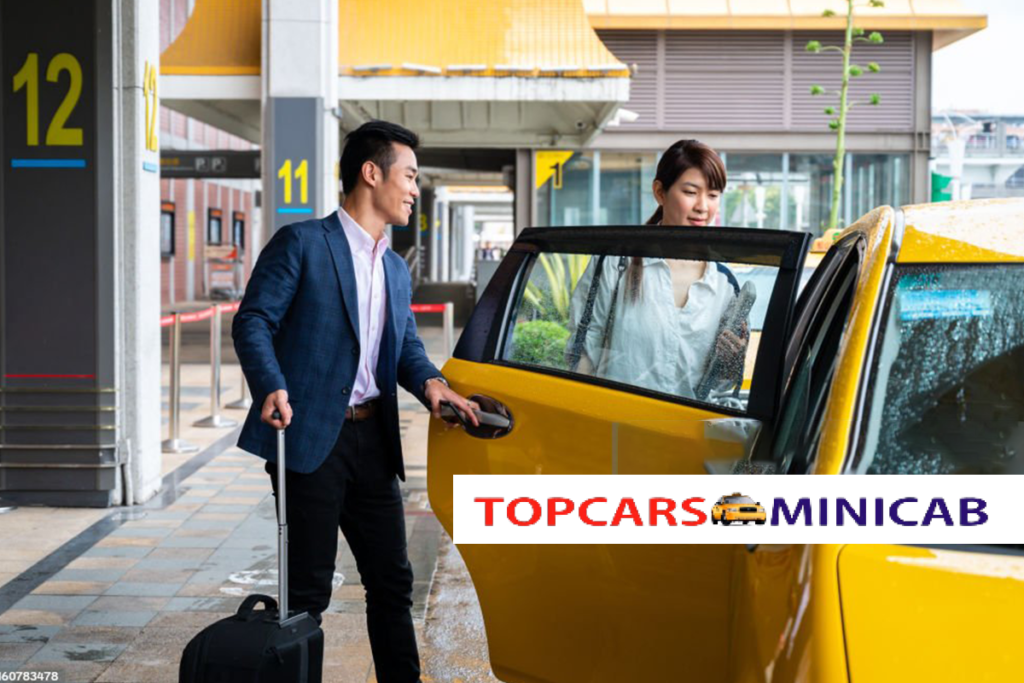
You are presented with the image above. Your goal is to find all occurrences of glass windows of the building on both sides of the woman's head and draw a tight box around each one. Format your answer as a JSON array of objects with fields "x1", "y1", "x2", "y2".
[{"x1": 537, "y1": 151, "x2": 910, "y2": 236}]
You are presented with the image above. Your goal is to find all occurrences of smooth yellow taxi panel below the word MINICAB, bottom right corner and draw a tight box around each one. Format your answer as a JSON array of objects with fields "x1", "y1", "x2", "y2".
[{"x1": 839, "y1": 545, "x2": 1024, "y2": 683}]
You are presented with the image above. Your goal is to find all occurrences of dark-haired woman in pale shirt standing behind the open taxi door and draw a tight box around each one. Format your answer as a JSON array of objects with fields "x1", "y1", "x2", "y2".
[{"x1": 567, "y1": 140, "x2": 749, "y2": 399}]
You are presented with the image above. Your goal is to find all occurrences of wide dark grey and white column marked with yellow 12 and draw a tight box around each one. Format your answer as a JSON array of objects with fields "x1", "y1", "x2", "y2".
[{"x1": 0, "y1": 0, "x2": 161, "y2": 507}]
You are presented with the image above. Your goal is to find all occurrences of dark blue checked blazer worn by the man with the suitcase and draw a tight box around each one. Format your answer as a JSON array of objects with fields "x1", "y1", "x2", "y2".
[{"x1": 231, "y1": 212, "x2": 441, "y2": 480}]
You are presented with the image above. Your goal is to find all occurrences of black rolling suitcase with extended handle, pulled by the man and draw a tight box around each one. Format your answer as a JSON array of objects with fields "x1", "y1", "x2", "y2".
[{"x1": 178, "y1": 416, "x2": 324, "y2": 683}]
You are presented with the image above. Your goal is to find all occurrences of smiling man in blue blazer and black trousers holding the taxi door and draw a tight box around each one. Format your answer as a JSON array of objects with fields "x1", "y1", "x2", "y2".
[{"x1": 231, "y1": 121, "x2": 477, "y2": 683}]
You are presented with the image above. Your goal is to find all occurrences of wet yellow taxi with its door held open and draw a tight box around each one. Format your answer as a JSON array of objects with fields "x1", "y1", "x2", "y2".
[{"x1": 427, "y1": 200, "x2": 1024, "y2": 683}]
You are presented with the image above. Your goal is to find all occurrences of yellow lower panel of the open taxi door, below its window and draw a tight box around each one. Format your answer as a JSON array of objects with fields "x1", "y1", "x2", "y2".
[{"x1": 427, "y1": 359, "x2": 742, "y2": 683}]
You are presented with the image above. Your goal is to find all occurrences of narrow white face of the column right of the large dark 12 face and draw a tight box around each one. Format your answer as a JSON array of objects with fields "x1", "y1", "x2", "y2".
[{"x1": 113, "y1": 0, "x2": 162, "y2": 505}]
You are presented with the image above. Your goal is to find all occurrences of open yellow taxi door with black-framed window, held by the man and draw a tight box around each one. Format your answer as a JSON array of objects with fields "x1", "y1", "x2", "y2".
[{"x1": 427, "y1": 225, "x2": 809, "y2": 683}]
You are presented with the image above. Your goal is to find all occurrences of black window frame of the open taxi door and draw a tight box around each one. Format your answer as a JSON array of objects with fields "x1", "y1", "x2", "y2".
[{"x1": 453, "y1": 225, "x2": 810, "y2": 420}]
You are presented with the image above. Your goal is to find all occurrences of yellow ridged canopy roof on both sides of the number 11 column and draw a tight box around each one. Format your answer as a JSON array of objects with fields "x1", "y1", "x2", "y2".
[{"x1": 161, "y1": 0, "x2": 630, "y2": 78}]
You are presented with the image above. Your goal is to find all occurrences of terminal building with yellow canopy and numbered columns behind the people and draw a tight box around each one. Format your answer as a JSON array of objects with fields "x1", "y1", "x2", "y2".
[{"x1": 0, "y1": 0, "x2": 986, "y2": 506}]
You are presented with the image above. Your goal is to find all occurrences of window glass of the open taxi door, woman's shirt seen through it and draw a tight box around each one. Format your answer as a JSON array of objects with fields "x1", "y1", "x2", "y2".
[{"x1": 503, "y1": 253, "x2": 778, "y2": 411}]
